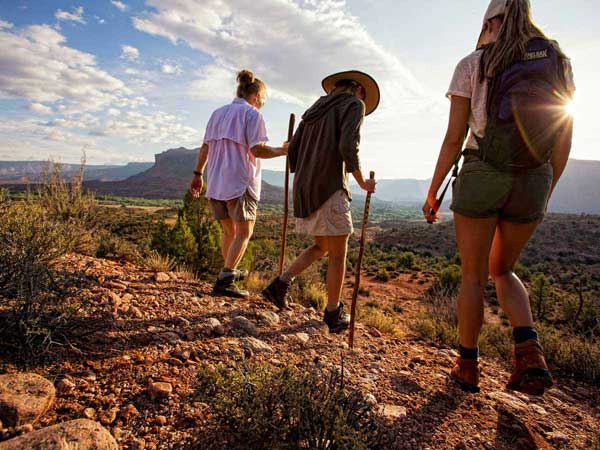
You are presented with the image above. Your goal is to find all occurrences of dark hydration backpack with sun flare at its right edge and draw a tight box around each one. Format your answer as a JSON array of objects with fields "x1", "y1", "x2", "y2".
[{"x1": 469, "y1": 38, "x2": 566, "y2": 171}]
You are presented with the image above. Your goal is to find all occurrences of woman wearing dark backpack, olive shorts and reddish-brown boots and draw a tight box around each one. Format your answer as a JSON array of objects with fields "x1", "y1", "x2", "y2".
[{"x1": 423, "y1": 0, "x2": 575, "y2": 395}]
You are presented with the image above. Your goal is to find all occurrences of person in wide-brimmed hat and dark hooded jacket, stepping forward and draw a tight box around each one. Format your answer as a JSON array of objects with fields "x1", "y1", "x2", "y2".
[{"x1": 263, "y1": 70, "x2": 380, "y2": 332}]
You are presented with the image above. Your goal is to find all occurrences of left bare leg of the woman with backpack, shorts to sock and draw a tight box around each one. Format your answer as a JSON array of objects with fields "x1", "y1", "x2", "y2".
[{"x1": 454, "y1": 213, "x2": 498, "y2": 348}]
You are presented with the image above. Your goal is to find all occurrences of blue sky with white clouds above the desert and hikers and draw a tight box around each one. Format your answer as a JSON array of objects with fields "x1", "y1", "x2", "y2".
[{"x1": 0, "y1": 0, "x2": 600, "y2": 179}]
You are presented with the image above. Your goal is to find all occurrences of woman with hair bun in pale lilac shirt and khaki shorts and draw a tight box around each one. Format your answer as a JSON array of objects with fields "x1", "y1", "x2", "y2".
[{"x1": 190, "y1": 70, "x2": 287, "y2": 298}]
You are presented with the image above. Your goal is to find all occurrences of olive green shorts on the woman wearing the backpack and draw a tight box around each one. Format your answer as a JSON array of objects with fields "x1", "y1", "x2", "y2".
[{"x1": 450, "y1": 159, "x2": 553, "y2": 223}]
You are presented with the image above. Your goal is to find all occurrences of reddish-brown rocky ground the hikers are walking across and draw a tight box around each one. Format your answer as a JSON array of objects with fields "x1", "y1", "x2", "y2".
[{"x1": 0, "y1": 256, "x2": 600, "y2": 450}]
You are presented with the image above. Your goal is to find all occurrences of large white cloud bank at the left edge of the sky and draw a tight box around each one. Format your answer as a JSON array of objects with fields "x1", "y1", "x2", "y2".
[{"x1": 0, "y1": 25, "x2": 132, "y2": 114}]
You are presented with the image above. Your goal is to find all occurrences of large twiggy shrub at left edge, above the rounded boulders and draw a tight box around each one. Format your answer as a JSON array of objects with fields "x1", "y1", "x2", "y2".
[{"x1": 0, "y1": 198, "x2": 84, "y2": 349}]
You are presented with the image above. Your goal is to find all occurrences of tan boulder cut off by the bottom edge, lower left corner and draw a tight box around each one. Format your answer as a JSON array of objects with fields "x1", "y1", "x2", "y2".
[{"x1": 0, "y1": 419, "x2": 119, "y2": 450}]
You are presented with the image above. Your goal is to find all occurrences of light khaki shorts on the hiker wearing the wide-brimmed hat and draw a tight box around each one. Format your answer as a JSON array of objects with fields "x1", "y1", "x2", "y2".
[{"x1": 296, "y1": 190, "x2": 354, "y2": 236}]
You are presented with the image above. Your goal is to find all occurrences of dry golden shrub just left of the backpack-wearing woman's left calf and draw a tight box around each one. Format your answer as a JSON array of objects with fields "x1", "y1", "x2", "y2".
[{"x1": 413, "y1": 286, "x2": 459, "y2": 347}]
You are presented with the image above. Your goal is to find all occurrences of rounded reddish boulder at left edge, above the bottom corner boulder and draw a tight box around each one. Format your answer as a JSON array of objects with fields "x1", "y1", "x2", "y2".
[{"x1": 0, "y1": 373, "x2": 56, "y2": 427}]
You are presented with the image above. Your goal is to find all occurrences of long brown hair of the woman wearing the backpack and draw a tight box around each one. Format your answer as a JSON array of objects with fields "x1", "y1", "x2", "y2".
[{"x1": 481, "y1": 0, "x2": 567, "y2": 81}]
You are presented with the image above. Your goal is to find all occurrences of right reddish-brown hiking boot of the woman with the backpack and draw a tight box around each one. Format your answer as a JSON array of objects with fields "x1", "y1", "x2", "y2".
[{"x1": 506, "y1": 339, "x2": 554, "y2": 395}]
